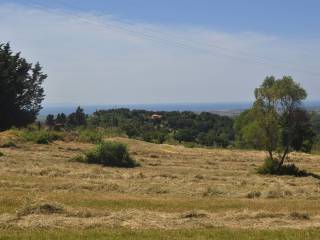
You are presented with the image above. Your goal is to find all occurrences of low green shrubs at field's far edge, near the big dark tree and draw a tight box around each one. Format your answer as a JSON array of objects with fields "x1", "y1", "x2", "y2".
[{"x1": 21, "y1": 130, "x2": 64, "y2": 144}]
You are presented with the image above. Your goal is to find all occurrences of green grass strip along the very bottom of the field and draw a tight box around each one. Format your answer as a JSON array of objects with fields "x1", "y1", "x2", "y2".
[{"x1": 0, "y1": 228, "x2": 320, "y2": 240}]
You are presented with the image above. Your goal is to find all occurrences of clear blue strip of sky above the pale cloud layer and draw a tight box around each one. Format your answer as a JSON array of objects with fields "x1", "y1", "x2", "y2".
[{"x1": 6, "y1": 0, "x2": 320, "y2": 38}]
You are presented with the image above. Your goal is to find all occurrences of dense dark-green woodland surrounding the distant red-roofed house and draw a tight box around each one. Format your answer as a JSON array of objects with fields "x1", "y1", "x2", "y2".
[{"x1": 88, "y1": 109, "x2": 234, "y2": 147}]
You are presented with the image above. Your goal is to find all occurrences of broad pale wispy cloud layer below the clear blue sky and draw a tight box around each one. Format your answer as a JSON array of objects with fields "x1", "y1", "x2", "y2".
[{"x1": 0, "y1": 5, "x2": 320, "y2": 104}]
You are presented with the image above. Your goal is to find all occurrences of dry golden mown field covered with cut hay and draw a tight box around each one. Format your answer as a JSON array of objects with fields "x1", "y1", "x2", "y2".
[{"x1": 0, "y1": 132, "x2": 320, "y2": 239}]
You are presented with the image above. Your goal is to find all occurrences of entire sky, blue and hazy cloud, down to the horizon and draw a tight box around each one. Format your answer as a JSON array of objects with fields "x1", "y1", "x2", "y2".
[{"x1": 0, "y1": 0, "x2": 320, "y2": 105}]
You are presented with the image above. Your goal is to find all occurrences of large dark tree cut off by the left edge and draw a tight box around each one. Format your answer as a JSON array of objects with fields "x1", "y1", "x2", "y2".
[{"x1": 0, "y1": 43, "x2": 47, "y2": 130}]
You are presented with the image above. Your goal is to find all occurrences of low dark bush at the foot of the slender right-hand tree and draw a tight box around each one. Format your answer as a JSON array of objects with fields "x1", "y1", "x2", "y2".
[{"x1": 258, "y1": 158, "x2": 310, "y2": 177}]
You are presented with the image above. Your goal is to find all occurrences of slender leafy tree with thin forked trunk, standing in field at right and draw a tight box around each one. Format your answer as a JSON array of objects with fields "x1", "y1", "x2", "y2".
[{"x1": 252, "y1": 76, "x2": 312, "y2": 167}]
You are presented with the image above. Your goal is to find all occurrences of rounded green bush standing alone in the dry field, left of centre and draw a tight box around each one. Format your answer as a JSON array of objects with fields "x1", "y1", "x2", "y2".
[{"x1": 85, "y1": 142, "x2": 139, "y2": 168}]
